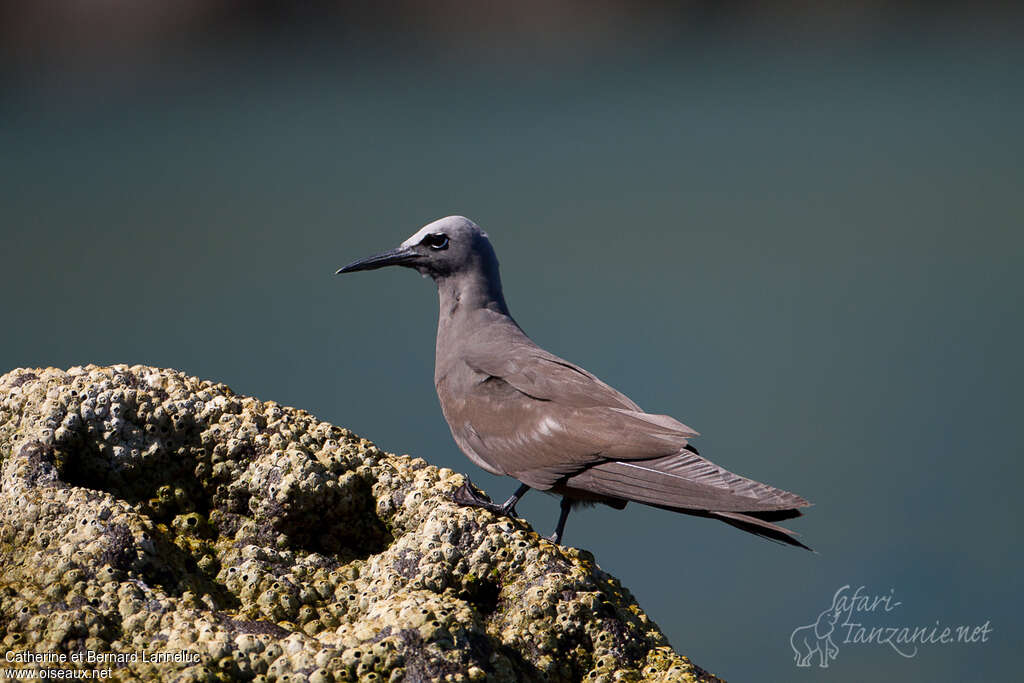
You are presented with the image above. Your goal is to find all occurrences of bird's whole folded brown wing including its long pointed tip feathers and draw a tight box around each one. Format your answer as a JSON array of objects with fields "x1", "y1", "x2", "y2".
[{"x1": 450, "y1": 317, "x2": 809, "y2": 513}]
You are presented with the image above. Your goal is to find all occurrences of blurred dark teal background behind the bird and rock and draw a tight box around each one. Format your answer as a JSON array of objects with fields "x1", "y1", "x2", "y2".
[{"x1": 0, "y1": 0, "x2": 1024, "y2": 682}]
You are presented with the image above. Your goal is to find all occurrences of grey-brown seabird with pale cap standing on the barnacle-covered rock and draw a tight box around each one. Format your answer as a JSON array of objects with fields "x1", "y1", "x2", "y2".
[{"x1": 336, "y1": 216, "x2": 811, "y2": 550}]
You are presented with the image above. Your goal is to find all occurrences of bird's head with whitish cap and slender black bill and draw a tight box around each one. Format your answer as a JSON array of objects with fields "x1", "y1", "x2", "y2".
[{"x1": 337, "y1": 216, "x2": 498, "y2": 281}]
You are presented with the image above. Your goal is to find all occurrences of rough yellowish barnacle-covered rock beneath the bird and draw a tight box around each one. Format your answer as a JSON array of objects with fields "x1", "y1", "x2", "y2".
[{"x1": 0, "y1": 366, "x2": 716, "y2": 683}]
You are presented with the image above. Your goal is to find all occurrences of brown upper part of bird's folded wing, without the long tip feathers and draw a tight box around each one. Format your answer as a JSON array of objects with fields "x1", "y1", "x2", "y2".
[{"x1": 450, "y1": 325, "x2": 697, "y2": 488}]
